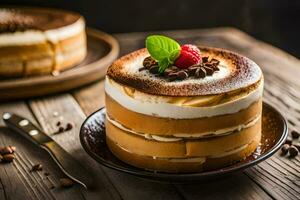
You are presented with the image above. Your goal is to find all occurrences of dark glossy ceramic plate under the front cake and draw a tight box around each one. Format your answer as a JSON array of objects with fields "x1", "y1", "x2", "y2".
[{"x1": 80, "y1": 103, "x2": 288, "y2": 182}]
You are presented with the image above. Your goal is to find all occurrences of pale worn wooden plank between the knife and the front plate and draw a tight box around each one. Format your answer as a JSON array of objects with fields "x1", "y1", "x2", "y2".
[{"x1": 29, "y1": 94, "x2": 121, "y2": 199}]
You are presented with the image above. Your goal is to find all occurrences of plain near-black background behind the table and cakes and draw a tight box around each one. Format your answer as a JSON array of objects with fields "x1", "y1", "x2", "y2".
[{"x1": 0, "y1": 0, "x2": 300, "y2": 58}]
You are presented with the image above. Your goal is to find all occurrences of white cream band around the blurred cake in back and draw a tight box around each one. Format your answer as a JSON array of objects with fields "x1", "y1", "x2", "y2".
[{"x1": 0, "y1": 18, "x2": 85, "y2": 47}]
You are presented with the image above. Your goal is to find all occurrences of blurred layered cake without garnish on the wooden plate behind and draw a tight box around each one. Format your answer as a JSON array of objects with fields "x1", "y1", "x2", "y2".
[{"x1": 0, "y1": 8, "x2": 86, "y2": 77}]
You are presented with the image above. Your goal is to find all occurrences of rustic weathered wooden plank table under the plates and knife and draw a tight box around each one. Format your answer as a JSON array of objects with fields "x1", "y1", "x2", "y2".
[{"x1": 0, "y1": 28, "x2": 300, "y2": 200}]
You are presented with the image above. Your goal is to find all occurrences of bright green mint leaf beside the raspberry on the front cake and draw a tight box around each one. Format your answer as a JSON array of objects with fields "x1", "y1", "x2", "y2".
[{"x1": 146, "y1": 35, "x2": 181, "y2": 73}]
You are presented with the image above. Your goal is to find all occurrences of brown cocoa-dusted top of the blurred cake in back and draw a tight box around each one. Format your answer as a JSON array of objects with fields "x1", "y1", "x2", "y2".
[{"x1": 0, "y1": 7, "x2": 81, "y2": 33}]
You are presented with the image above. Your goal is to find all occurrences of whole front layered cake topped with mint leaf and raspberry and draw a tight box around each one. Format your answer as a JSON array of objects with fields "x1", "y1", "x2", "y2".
[{"x1": 105, "y1": 36, "x2": 263, "y2": 173}]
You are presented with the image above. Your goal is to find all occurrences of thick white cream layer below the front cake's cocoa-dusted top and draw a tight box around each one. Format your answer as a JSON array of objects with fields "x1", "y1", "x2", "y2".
[{"x1": 105, "y1": 76, "x2": 263, "y2": 119}]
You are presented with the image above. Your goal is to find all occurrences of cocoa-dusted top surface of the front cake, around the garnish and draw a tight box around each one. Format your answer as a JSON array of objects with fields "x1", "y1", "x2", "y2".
[{"x1": 107, "y1": 46, "x2": 262, "y2": 96}]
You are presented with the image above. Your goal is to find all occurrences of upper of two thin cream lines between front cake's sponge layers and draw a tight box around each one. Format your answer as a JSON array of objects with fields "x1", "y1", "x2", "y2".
[{"x1": 106, "y1": 115, "x2": 261, "y2": 142}]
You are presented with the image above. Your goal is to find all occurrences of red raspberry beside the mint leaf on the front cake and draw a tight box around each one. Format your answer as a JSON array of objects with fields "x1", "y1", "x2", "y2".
[{"x1": 175, "y1": 44, "x2": 201, "y2": 69}]
